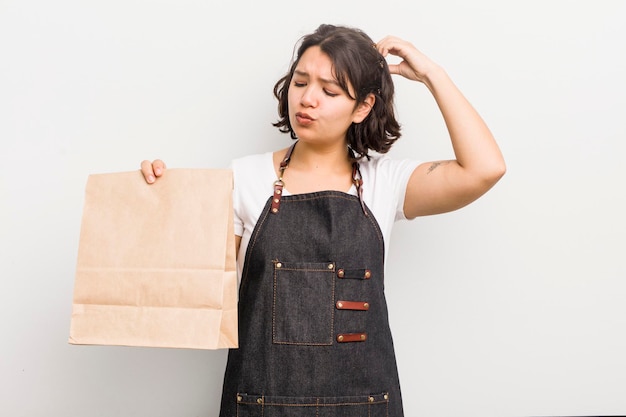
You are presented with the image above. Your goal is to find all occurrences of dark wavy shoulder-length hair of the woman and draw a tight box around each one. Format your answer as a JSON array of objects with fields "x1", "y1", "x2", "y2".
[{"x1": 273, "y1": 24, "x2": 400, "y2": 158}]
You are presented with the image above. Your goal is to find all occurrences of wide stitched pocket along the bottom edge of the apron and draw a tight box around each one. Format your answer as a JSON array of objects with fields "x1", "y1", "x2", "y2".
[{"x1": 237, "y1": 393, "x2": 389, "y2": 417}]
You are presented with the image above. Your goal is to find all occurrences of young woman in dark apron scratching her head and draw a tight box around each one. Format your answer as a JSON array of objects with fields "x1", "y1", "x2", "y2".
[{"x1": 141, "y1": 25, "x2": 505, "y2": 417}]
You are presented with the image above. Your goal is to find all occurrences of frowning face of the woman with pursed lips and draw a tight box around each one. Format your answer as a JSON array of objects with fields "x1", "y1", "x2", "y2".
[{"x1": 288, "y1": 46, "x2": 371, "y2": 144}]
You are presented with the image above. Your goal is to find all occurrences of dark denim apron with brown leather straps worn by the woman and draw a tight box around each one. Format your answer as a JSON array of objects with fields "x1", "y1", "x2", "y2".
[{"x1": 220, "y1": 142, "x2": 403, "y2": 417}]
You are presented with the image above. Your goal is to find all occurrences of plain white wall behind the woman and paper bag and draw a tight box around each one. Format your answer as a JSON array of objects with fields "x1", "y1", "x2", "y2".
[{"x1": 0, "y1": 0, "x2": 626, "y2": 417}]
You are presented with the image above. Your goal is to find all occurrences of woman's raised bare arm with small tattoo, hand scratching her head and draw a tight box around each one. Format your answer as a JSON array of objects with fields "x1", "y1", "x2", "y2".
[{"x1": 376, "y1": 36, "x2": 506, "y2": 218}]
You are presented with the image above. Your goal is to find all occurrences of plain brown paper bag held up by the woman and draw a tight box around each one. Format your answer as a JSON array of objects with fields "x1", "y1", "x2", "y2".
[{"x1": 69, "y1": 169, "x2": 238, "y2": 349}]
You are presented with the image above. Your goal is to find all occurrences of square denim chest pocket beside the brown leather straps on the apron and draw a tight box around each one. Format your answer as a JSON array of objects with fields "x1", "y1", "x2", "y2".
[{"x1": 272, "y1": 261, "x2": 336, "y2": 345}]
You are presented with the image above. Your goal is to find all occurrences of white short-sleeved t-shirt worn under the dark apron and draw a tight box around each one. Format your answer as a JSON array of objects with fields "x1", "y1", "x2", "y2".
[{"x1": 232, "y1": 152, "x2": 418, "y2": 277}]
